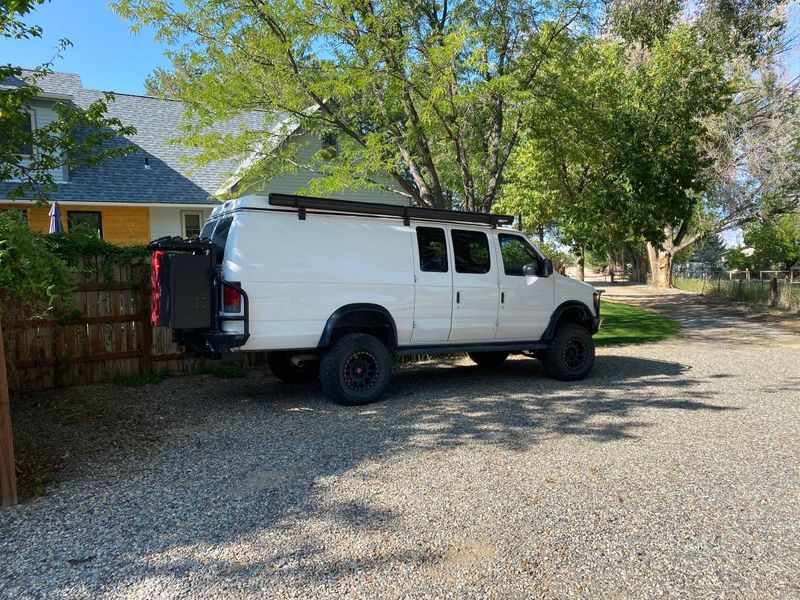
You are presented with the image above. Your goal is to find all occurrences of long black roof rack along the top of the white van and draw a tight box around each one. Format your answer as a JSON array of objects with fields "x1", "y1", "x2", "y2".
[{"x1": 269, "y1": 194, "x2": 514, "y2": 227}]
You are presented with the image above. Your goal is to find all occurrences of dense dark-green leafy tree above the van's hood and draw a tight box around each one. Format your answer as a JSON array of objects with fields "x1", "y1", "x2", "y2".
[{"x1": 500, "y1": 26, "x2": 728, "y2": 282}]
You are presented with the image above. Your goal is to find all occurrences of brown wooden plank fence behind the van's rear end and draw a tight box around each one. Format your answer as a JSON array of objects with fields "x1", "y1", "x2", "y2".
[{"x1": 5, "y1": 257, "x2": 209, "y2": 391}]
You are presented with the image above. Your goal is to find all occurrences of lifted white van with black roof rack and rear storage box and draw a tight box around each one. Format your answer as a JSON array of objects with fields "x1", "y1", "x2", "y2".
[{"x1": 151, "y1": 194, "x2": 600, "y2": 405}]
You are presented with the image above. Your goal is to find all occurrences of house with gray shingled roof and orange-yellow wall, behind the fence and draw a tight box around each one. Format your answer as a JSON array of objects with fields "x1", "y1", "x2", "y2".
[{"x1": 0, "y1": 73, "x2": 407, "y2": 244}]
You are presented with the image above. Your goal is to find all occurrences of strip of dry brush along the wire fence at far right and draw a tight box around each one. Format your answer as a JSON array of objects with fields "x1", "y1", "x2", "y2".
[{"x1": 673, "y1": 271, "x2": 800, "y2": 311}]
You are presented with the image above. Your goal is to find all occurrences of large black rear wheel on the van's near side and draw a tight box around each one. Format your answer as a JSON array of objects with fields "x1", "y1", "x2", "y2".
[{"x1": 319, "y1": 333, "x2": 392, "y2": 406}]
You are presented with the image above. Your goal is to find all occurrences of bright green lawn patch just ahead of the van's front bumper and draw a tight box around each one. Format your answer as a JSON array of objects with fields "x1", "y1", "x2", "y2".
[{"x1": 594, "y1": 301, "x2": 681, "y2": 346}]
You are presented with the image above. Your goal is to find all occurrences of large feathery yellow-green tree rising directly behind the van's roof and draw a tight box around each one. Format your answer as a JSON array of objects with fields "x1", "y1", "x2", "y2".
[{"x1": 113, "y1": 0, "x2": 588, "y2": 211}]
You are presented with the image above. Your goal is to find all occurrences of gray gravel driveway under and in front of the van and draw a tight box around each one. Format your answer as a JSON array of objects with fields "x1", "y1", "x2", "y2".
[{"x1": 0, "y1": 286, "x2": 800, "y2": 599}]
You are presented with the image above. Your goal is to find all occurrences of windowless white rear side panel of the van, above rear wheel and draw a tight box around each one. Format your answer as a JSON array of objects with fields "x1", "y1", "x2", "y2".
[{"x1": 223, "y1": 207, "x2": 414, "y2": 350}]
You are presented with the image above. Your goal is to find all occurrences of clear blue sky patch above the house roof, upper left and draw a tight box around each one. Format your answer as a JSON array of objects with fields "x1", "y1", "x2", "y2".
[{"x1": 0, "y1": 0, "x2": 168, "y2": 94}]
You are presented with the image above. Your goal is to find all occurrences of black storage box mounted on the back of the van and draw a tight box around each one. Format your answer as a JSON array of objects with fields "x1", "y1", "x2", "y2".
[{"x1": 158, "y1": 252, "x2": 213, "y2": 329}]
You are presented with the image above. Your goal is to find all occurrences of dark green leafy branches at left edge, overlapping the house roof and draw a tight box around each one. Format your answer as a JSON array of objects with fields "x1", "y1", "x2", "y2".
[{"x1": 0, "y1": 0, "x2": 136, "y2": 201}]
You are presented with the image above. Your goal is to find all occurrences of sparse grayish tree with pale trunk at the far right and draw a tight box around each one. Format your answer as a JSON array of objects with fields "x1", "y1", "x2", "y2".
[{"x1": 610, "y1": 0, "x2": 800, "y2": 286}]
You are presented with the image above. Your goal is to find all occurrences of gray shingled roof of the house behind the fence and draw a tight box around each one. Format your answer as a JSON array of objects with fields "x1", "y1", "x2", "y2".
[{"x1": 0, "y1": 73, "x2": 274, "y2": 204}]
